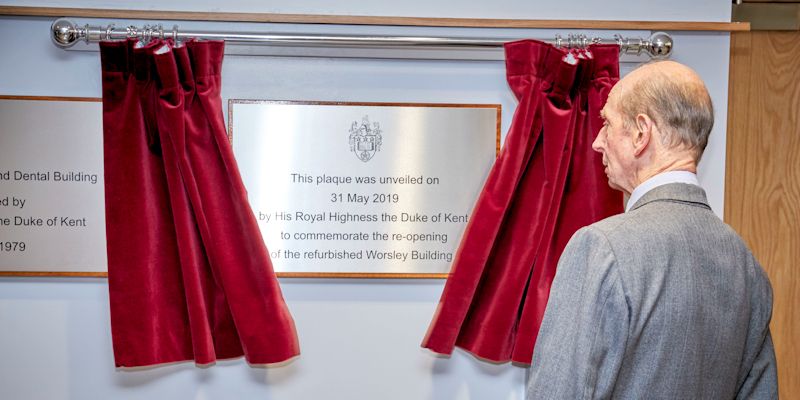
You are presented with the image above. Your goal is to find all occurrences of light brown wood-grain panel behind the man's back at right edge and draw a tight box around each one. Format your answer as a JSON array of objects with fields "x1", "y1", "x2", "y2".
[{"x1": 725, "y1": 31, "x2": 800, "y2": 399}]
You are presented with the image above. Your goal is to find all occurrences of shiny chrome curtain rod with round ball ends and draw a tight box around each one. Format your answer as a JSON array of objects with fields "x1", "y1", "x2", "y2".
[{"x1": 51, "y1": 18, "x2": 672, "y2": 58}]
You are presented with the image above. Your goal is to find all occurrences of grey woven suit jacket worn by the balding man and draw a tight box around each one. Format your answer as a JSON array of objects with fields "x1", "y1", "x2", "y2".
[{"x1": 527, "y1": 183, "x2": 778, "y2": 399}]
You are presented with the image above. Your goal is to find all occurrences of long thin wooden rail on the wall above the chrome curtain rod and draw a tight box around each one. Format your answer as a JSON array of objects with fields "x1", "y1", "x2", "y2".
[{"x1": 0, "y1": 6, "x2": 750, "y2": 31}]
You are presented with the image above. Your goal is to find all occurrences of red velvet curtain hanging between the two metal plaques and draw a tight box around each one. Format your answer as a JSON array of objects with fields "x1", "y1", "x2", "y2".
[{"x1": 100, "y1": 40, "x2": 299, "y2": 367}]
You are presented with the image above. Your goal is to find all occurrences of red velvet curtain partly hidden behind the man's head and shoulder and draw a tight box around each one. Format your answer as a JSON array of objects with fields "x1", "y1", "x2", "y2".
[{"x1": 422, "y1": 40, "x2": 622, "y2": 364}]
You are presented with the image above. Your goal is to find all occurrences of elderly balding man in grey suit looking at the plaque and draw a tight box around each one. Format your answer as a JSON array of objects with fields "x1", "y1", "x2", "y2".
[{"x1": 527, "y1": 61, "x2": 778, "y2": 399}]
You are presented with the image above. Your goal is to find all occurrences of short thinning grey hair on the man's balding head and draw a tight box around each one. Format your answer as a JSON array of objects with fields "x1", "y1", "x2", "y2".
[{"x1": 619, "y1": 61, "x2": 714, "y2": 161}]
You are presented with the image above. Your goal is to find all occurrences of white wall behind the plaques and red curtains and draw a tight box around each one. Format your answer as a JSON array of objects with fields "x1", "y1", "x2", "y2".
[{"x1": 0, "y1": 0, "x2": 730, "y2": 400}]
